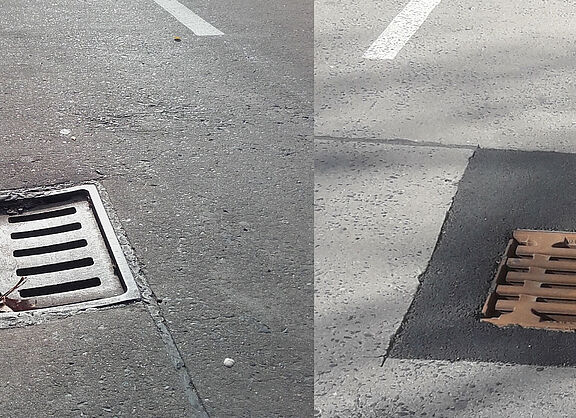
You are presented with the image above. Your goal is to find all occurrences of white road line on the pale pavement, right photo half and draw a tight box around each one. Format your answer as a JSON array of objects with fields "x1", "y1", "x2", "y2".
[{"x1": 363, "y1": 0, "x2": 442, "y2": 60}]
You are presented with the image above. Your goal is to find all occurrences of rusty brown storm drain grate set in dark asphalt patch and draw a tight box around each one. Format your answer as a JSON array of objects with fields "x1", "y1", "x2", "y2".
[{"x1": 482, "y1": 230, "x2": 576, "y2": 330}]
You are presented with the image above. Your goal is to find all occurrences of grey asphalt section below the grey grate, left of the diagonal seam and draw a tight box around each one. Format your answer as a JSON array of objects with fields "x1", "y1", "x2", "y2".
[{"x1": 0, "y1": 304, "x2": 197, "y2": 417}]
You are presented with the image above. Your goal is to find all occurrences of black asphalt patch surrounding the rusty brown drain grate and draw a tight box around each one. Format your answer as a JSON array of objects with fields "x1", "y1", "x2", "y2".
[{"x1": 389, "y1": 149, "x2": 576, "y2": 365}]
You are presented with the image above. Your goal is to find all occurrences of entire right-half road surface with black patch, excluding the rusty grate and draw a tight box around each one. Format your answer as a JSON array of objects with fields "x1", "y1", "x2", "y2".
[{"x1": 315, "y1": 0, "x2": 576, "y2": 417}]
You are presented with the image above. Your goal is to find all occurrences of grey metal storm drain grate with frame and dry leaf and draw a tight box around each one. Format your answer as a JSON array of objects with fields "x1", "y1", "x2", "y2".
[{"x1": 0, "y1": 185, "x2": 139, "y2": 310}]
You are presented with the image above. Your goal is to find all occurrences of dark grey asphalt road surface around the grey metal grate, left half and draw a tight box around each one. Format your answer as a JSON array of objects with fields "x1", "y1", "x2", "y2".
[{"x1": 0, "y1": 0, "x2": 313, "y2": 417}]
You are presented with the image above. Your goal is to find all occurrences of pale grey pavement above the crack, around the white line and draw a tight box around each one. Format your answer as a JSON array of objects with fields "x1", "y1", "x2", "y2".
[{"x1": 315, "y1": 0, "x2": 576, "y2": 152}]
